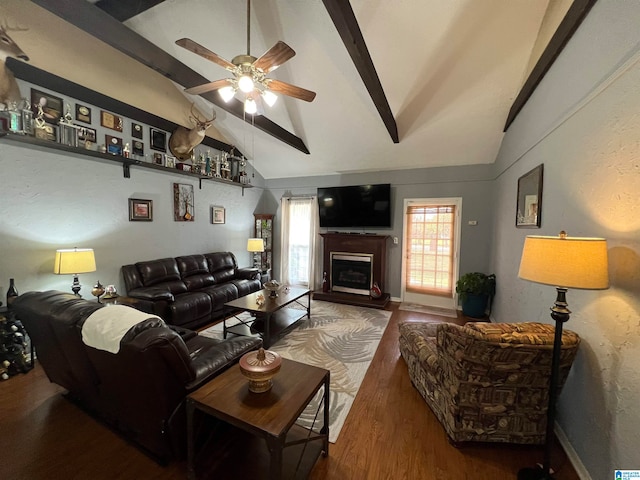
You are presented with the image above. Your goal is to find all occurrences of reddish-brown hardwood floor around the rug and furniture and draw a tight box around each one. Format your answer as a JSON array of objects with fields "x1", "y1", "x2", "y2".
[{"x1": 0, "y1": 303, "x2": 579, "y2": 480}]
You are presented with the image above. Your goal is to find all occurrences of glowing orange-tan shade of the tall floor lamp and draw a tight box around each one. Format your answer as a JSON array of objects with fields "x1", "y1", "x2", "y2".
[{"x1": 518, "y1": 232, "x2": 609, "y2": 290}]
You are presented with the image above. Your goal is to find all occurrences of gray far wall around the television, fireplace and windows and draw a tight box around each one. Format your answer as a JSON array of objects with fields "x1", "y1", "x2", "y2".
[{"x1": 261, "y1": 165, "x2": 493, "y2": 298}]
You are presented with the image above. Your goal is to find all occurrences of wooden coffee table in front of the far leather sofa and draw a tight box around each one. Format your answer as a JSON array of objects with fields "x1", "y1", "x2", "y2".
[{"x1": 223, "y1": 288, "x2": 311, "y2": 348}]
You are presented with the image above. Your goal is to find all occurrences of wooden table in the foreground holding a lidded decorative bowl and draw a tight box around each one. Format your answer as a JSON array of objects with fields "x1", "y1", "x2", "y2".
[{"x1": 187, "y1": 358, "x2": 330, "y2": 480}]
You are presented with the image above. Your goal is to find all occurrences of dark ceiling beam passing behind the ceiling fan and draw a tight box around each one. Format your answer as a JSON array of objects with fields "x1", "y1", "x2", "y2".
[{"x1": 32, "y1": 0, "x2": 309, "y2": 154}]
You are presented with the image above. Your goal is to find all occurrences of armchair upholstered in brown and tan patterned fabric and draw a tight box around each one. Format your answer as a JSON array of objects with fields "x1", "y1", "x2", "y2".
[{"x1": 399, "y1": 322, "x2": 580, "y2": 444}]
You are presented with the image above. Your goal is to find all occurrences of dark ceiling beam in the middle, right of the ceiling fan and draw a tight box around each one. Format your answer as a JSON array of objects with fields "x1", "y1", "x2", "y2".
[{"x1": 322, "y1": 0, "x2": 400, "y2": 143}]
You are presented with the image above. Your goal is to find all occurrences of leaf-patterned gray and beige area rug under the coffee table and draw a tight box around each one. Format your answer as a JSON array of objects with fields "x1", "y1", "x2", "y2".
[{"x1": 200, "y1": 300, "x2": 391, "y2": 443}]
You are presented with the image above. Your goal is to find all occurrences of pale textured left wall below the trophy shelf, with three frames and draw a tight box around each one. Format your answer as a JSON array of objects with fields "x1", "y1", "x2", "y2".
[{"x1": 0, "y1": 140, "x2": 262, "y2": 299}]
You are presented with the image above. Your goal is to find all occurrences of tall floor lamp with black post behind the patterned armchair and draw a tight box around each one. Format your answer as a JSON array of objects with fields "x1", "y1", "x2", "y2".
[{"x1": 518, "y1": 231, "x2": 609, "y2": 480}]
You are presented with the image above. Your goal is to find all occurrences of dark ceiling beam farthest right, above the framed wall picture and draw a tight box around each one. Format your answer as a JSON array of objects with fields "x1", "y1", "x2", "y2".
[{"x1": 504, "y1": 0, "x2": 597, "y2": 132}]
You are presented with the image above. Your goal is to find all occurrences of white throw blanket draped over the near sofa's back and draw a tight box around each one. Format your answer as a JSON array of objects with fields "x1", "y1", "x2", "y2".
[{"x1": 82, "y1": 305, "x2": 162, "y2": 353}]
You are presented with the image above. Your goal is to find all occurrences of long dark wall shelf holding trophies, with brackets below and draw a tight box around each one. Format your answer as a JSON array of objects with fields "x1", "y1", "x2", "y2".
[{"x1": 0, "y1": 132, "x2": 253, "y2": 193}]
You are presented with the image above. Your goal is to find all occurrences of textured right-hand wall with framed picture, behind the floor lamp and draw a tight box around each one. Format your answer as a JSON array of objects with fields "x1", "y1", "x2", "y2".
[{"x1": 494, "y1": 0, "x2": 640, "y2": 480}]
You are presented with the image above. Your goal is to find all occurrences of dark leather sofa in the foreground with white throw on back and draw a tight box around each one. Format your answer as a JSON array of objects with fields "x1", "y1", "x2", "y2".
[{"x1": 13, "y1": 291, "x2": 262, "y2": 463}]
